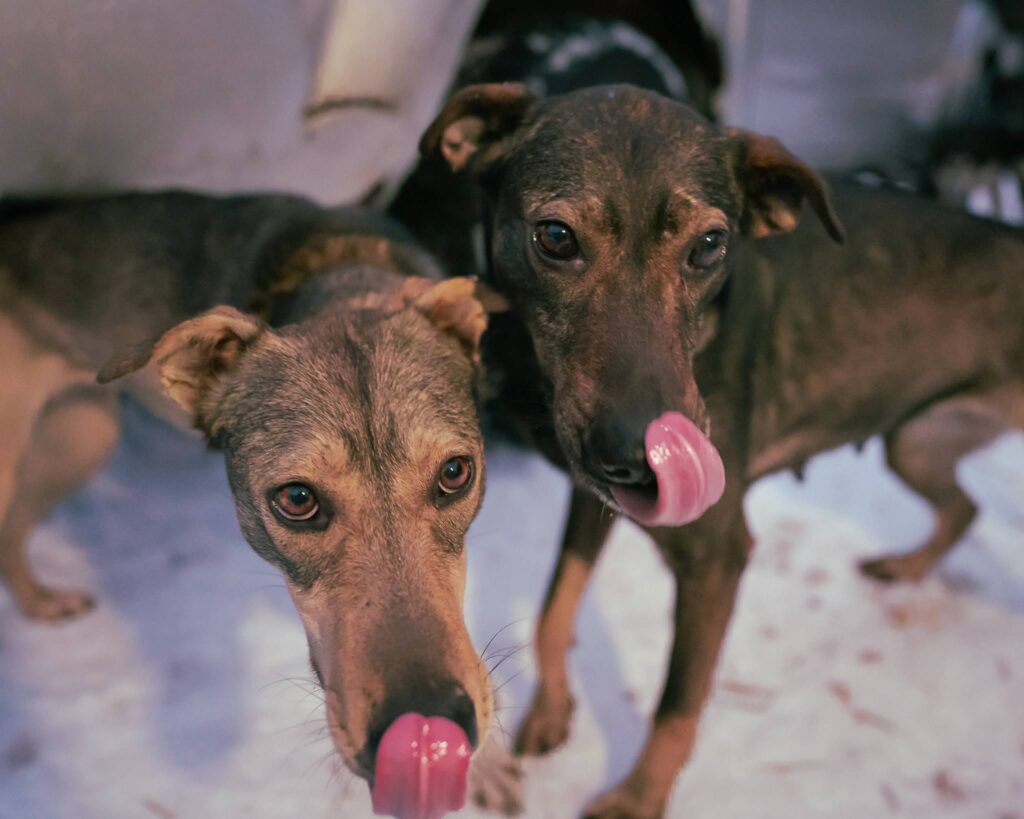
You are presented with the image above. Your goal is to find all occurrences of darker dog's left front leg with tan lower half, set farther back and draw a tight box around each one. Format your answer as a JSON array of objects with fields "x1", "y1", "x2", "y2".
[{"x1": 515, "y1": 487, "x2": 615, "y2": 755}]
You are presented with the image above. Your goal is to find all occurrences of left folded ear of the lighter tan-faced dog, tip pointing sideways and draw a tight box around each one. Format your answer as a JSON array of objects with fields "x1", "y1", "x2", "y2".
[{"x1": 96, "y1": 306, "x2": 266, "y2": 434}]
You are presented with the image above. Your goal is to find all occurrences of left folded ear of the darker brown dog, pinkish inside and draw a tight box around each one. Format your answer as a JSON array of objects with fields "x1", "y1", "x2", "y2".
[{"x1": 420, "y1": 83, "x2": 535, "y2": 173}]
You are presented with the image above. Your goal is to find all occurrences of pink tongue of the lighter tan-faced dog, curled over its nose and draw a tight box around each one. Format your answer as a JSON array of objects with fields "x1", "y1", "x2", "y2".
[{"x1": 373, "y1": 714, "x2": 472, "y2": 819}]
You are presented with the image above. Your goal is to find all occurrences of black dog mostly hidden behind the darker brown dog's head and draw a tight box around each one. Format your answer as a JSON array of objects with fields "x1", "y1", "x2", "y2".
[{"x1": 389, "y1": 0, "x2": 722, "y2": 288}]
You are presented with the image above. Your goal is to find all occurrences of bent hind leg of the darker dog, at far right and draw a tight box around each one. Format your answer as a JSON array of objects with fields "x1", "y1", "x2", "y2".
[{"x1": 860, "y1": 396, "x2": 1006, "y2": 583}]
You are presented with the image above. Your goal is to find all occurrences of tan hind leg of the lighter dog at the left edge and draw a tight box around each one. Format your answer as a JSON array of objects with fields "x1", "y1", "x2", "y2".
[{"x1": 0, "y1": 387, "x2": 118, "y2": 621}]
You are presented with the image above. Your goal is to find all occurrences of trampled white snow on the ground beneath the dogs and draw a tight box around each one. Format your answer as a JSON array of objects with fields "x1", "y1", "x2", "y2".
[{"x1": 0, "y1": 399, "x2": 1024, "y2": 819}]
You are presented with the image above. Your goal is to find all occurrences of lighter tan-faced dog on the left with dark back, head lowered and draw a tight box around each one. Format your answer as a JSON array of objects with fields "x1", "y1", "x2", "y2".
[{"x1": 0, "y1": 192, "x2": 515, "y2": 808}]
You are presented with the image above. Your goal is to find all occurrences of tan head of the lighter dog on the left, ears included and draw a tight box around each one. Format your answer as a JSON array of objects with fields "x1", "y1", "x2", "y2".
[{"x1": 108, "y1": 279, "x2": 492, "y2": 776}]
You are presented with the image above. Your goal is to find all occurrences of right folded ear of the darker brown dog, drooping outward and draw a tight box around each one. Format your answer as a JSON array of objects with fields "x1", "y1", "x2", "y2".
[{"x1": 728, "y1": 128, "x2": 844, "y2": 243}]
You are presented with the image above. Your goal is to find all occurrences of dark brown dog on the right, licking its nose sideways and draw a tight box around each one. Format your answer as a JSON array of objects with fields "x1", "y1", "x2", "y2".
[{"x1": 407, "y1": 84, "x2": 1024, "y2": 817}]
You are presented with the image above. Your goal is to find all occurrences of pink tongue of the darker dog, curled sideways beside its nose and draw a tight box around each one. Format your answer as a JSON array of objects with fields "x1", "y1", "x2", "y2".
[{"x1": 611, "y1": 413, "x2": 725, "y2": 526}]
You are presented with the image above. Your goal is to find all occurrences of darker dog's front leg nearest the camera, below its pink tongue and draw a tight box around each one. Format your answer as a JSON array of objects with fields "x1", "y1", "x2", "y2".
[{"x1": 585, "y1": 503, "x2": 751, "y2": 819}]
